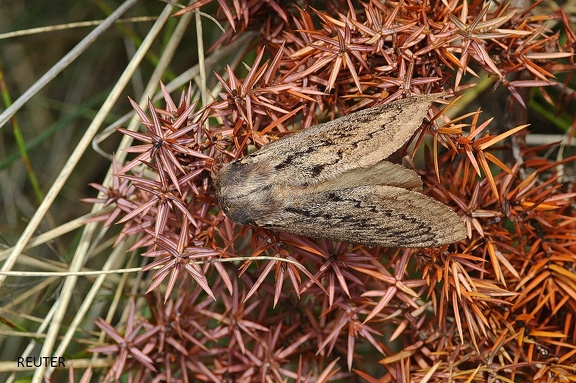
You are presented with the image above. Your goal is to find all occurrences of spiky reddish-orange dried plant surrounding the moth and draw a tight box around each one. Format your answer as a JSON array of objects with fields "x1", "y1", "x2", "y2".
[{"x1": 57, "y1": 0, "x2": 576, "y2": 382}]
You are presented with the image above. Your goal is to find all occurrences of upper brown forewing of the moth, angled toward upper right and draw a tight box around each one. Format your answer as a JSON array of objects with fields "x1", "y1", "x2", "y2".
[{"x1": 240, "y1": 94, "x2": 439, "y2": 186}]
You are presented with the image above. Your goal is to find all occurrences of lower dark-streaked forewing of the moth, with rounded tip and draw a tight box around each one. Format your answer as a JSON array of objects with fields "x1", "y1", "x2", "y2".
[{"x1": 255, "y1": 185, "x2": 466, "y2": 247}]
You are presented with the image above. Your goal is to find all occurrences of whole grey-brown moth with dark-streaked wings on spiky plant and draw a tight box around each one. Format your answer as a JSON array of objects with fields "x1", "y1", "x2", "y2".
[{"x1": 214, "y1": 95, "x2": 466, "y2": 247}]
